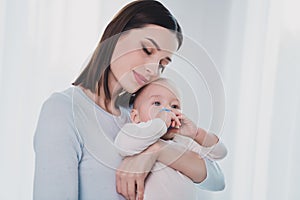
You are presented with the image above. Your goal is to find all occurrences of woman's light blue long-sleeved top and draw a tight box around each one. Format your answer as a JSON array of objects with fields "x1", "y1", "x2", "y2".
[{"x1": 33, "y1": 87, "x2": 225, "y2": 200}]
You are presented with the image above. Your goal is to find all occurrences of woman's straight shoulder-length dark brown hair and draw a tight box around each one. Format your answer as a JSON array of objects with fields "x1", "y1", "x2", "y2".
[{"x1": 73, "y1": 0, "x2": 183, "y2": 104}]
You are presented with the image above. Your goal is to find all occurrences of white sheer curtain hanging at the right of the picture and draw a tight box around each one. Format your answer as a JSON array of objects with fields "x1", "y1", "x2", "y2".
[{"x1": 220, "y1": 0, "x2": 300, "y2": 199}]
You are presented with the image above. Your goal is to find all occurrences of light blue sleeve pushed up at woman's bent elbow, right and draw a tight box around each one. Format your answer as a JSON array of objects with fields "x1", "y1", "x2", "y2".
[{"x1": 195, "y1": 158, "x2": 225, "y2": 191}]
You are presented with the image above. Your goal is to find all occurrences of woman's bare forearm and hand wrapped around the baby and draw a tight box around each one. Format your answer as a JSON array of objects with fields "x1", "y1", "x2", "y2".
[{"x1": 116, "y1": 140, "x2": 206, "y2": 199}]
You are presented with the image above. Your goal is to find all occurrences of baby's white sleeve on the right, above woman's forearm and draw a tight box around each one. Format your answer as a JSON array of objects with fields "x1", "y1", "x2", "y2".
[{"x1": 173, "y1": 134, "x2": 227, "y2": 160}]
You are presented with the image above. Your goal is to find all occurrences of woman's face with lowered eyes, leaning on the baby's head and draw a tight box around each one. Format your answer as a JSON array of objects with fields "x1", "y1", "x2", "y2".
[{"x1": 110, "y1": 25, "x2": 178, "y2": 93}]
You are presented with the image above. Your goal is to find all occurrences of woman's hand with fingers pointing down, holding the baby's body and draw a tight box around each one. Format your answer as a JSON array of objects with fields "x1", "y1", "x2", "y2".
[{"x1": 116, "y1": 142, "x2": 160, "y2": 200}]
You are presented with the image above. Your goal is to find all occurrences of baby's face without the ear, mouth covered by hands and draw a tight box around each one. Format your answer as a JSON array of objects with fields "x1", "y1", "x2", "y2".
[{"x1": 135, "y1": 83, "x2": 181, "y2": 122}]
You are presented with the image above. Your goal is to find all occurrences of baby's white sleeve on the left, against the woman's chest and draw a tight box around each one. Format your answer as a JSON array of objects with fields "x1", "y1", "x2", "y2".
[{"x1": 114, "y1": 118, "x2": 167, "y2": 156}]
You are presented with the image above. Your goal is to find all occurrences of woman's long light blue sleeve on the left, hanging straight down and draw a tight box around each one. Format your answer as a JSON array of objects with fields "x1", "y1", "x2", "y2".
[{"x1": 33, "y1": 94, "x2": 82, "y2": 200}]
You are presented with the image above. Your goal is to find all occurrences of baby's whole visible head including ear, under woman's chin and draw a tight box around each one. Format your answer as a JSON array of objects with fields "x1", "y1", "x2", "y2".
[{"x1": 130, "y1": 78, "x2": 181, "y2": 123}]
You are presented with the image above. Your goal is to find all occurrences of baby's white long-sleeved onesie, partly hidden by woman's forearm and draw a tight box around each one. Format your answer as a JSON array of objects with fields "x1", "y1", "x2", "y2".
[{"x1": 114, "y1": 118, "x2": 227, "y2": 200}]
